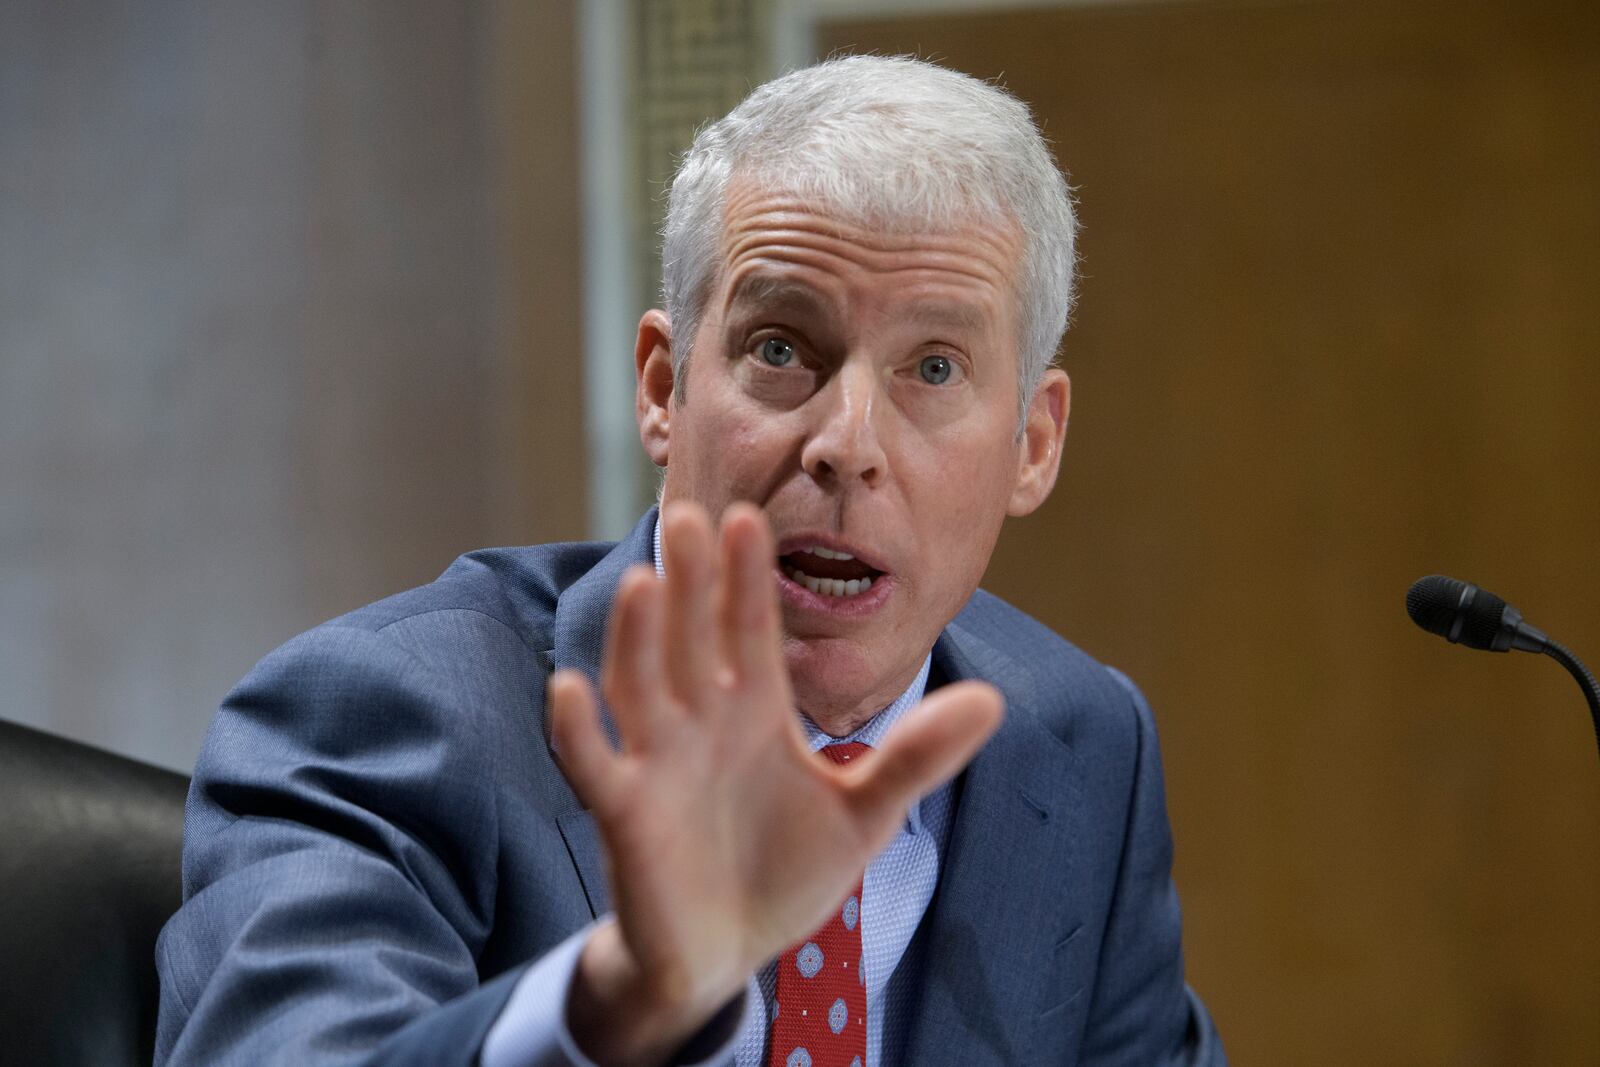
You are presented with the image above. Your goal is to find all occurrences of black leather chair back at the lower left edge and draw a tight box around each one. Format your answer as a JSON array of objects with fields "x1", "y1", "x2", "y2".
[{"x1": 0, "y1": 721, "x2": 189, "y2": 1067}]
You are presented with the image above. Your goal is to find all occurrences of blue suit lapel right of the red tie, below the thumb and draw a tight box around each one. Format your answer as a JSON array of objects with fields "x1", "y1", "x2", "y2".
[{"x1": 883, "y1": 624, "x2": 1082, "y2": 1067}]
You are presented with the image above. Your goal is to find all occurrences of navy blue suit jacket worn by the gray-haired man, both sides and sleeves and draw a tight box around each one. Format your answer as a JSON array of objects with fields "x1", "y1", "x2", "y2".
[{"x1": 155, "y1": 514, "x2": 1224, "y2": 1067}]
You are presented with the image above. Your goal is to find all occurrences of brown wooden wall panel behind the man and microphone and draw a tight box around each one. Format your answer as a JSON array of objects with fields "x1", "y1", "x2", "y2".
[{"x1": 821, "y1": 2, "x2": 1600, "y2": 1065}]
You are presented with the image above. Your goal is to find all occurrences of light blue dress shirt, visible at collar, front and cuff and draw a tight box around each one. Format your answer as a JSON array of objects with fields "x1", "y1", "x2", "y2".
[{"x1": 480, "y1": 522, "x2": 952, "y2": 1067}]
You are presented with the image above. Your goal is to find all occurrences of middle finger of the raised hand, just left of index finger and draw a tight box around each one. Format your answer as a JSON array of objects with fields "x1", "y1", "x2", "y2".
[{"x1": 661, "y1": 504, "x2": 717, "y2": 710}]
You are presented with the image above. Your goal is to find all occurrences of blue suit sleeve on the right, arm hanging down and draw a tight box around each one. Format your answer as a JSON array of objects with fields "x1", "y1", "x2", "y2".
[{"x1": 1082, "y1": 670, "x2": 1227, "y2": 1067}]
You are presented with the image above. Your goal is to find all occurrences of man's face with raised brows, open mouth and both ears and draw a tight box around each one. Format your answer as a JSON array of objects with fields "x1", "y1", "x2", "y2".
[{"x1": 637, "y1": 182, "x2": 1067, "y2": 734}]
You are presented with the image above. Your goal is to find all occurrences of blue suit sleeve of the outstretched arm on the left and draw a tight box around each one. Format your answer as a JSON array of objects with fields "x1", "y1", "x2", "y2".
[{"x1": 155, "y1": 627, "x2": 547, "y2": 1067}]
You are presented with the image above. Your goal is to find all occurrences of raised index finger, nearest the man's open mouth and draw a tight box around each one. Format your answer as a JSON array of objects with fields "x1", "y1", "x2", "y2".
[{"x1": 718, "y1": 504, "x2": 787, "y2": 689}]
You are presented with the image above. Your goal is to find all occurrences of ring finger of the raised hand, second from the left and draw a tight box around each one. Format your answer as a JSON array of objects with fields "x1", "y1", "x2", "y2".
[{"x1": 600, "y1": 566, "x2": 674, "y2": 750}]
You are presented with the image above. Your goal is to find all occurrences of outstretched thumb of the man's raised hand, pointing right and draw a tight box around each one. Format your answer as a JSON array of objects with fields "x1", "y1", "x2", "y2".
[{"x1": 843, "y1": 681, "x2": 1005, "y2": 832}]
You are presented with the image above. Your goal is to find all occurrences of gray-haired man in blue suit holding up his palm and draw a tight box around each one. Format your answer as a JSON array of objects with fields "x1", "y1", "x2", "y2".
[{"x1": 157, "y1": 58, "x2": 1224, "y2": 1067}]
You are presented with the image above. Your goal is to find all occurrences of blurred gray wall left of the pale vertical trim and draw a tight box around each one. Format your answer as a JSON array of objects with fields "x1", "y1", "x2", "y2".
[{"x1": 0, "y1": 0, "x2": 584, "y2": 769}]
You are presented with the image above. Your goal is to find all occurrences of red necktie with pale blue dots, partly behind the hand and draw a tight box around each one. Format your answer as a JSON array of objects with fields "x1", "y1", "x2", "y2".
[{"x1": 766, "y1": 741, "x2": 867, "y2": 1067}]
